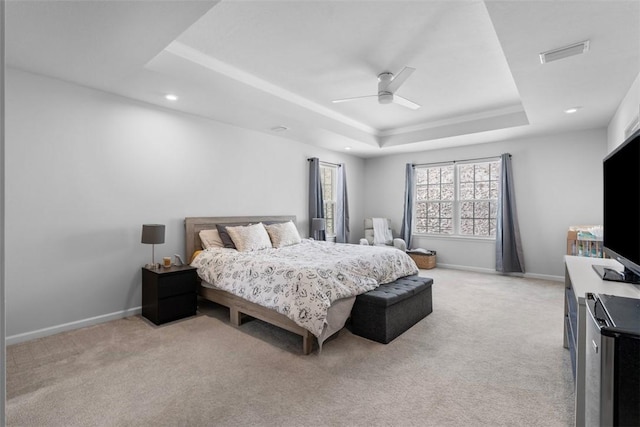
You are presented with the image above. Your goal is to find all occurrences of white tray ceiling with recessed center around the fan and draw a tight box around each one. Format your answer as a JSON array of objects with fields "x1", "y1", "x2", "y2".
[{"x1": 5, "y1": 0, "x2": 640, "y2": 157}]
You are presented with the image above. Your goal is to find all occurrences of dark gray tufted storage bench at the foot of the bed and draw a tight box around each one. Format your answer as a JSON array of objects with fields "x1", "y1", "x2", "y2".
[{"x1": 351, "y1": 276, "x2": 433, "y2": 344}]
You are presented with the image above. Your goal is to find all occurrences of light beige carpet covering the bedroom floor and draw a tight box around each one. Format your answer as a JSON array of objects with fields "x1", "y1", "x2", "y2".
[{"x1": 6, "y1": 268, "x2": 574, "y2": 426}]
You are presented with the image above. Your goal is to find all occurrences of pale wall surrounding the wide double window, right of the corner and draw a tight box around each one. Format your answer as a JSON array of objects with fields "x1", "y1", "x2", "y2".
[{"x1": 364, "y1": 129, "x2": 607, "y2": 277}]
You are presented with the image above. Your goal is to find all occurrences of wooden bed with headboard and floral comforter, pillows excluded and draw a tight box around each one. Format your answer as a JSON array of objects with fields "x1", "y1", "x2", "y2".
[{"x1": 185, "y1": 215, "x2": 418, "y2": 354}]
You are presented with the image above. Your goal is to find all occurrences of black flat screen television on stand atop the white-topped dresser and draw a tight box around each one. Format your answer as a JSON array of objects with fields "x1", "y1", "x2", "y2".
[{"x1": 594, "y1": 130, "x2": 640, "y2": 284}]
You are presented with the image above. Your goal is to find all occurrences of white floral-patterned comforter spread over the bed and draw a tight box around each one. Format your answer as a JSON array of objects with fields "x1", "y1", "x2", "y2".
[{"x1": 191, "y1": 239, "x2": 418, "y2": 337}]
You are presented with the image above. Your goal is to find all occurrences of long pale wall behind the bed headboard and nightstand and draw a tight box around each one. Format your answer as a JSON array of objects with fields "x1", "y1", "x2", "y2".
[{"x1": 5, "y1": 69, "x2": 364, "y2": 342}]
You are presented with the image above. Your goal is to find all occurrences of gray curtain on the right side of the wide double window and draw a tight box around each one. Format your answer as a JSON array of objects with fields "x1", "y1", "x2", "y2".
[{"x1": 496, "y1": 154, "x2": 524, "y2": 273}]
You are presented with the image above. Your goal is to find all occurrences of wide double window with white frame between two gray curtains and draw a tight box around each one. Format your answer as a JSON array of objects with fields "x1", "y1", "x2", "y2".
[{"x1": 414, "y1": 160, "x2": 500, "y2": 237}]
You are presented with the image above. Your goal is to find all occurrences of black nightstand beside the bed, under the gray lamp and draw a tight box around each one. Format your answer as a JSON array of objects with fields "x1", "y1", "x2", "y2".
[{"x1": 142, "y1": 265, "x2": 198, "y2": 325}]
